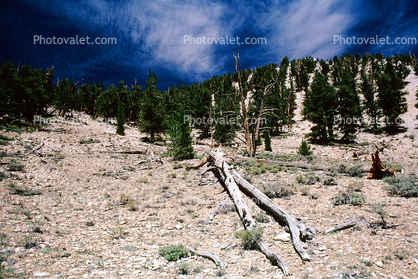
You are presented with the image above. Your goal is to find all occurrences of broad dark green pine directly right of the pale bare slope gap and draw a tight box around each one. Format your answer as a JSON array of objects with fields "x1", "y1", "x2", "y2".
[{"x1": 302, "y1": 70, "x2": 337, "y2": 142}]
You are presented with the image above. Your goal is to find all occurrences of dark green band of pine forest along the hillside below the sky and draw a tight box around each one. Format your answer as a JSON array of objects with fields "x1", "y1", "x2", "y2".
[{"x1": 0, "y1": 53, "x2": 418, "y2": 159}]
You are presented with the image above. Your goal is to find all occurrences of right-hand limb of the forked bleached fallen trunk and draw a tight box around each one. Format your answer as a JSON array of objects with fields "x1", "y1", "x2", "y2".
[{"x1": 232, "y1": 170, "x2": 312, "y2": 261}]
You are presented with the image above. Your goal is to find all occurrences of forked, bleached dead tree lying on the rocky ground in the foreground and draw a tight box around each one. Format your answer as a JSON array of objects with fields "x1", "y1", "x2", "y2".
[{"x1": 191, "y1": 149, "x2": 311, "y2": 275}]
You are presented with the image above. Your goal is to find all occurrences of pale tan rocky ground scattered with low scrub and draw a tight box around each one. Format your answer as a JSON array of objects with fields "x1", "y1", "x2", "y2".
[{"x1": 0, "y1": 71, "x2": 418, "y2": 278}]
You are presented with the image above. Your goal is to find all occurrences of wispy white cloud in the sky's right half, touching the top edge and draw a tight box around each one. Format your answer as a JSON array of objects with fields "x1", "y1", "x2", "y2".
[{"x1": 268, "y1": 0, "x2": 355, "y2": 58}]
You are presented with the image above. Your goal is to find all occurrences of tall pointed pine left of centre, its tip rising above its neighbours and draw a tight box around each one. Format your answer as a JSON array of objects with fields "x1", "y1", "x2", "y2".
[{"x1": 139, "y1": 69, "x2": 166, "y2": 142}]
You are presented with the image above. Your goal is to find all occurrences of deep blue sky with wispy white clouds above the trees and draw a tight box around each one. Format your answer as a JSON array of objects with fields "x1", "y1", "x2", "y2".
[{"x1": 0, "y1": 0, "x2": 418, "y2": 89}]
